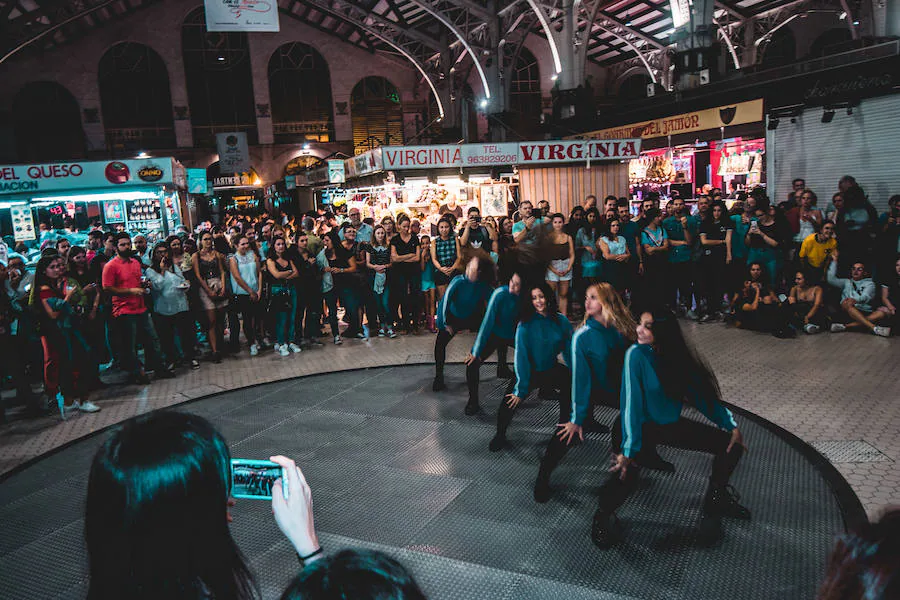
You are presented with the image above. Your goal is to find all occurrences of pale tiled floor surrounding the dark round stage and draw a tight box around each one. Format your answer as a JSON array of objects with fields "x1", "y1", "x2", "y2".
[{"x1": 0, "y1": 323, "x2": 900, "y2": 516}]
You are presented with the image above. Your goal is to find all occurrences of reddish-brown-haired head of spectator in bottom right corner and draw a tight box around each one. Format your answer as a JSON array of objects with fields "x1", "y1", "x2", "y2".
[{"x1": 816, "y1": 508, "x2": 900, "y2": 600}]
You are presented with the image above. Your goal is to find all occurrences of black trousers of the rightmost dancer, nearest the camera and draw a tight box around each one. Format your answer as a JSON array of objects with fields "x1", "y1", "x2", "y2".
[{"x1": 598, "y1": 417, "x2": 744, "y2": 513}]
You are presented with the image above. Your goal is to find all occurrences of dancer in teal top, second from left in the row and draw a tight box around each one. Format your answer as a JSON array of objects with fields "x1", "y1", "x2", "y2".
[{"x1": 466, "y1": 273, "x2": 522, "y2": 415}]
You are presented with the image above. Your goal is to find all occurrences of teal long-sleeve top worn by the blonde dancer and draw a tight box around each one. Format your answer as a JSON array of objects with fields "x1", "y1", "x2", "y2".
[{"x1": 572, "y1": 318, "x2": 628, "y2": 425}]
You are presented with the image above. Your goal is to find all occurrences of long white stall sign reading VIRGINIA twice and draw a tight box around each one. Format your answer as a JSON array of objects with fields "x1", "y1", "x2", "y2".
[{"x1": 382, "y1": 139, "x2": 641, "y2": 170}]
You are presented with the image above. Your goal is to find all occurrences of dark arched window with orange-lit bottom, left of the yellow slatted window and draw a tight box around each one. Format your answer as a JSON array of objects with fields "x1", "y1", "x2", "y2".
[{"x1": 269, "y1": 42, "x2": 334, "y2": 143}]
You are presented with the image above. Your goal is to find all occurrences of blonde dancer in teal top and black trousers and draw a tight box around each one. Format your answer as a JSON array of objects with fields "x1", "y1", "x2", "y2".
[{"x1": 534, "y1": 283, "x2": 637, "y2": 503}]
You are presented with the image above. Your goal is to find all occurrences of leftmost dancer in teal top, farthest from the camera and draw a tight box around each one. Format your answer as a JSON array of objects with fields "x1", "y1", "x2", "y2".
[{"x1": 431, "y1": 256, "x2": 497, "y2": 392}]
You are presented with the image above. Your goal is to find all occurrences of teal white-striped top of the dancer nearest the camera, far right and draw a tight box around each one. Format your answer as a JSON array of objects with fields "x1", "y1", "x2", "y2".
[{"x1": 620, "y1": 344, "x2": 737, "y2": 458}]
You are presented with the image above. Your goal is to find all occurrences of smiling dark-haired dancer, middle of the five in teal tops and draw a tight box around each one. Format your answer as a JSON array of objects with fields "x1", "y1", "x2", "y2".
[{"x1": 488, "y1": 283, "x2": 572, "y2": 452}]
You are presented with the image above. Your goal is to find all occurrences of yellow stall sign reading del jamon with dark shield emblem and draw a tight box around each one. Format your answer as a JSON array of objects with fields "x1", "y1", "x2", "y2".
[{"x1": 578, "y1": 100, "x2": 763, "y2": 140}]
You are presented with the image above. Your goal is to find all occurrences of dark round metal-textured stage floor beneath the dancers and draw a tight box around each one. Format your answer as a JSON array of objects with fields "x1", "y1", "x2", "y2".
[{"x1": 0, "y1": 365, "x2": 864, "y2": 600}]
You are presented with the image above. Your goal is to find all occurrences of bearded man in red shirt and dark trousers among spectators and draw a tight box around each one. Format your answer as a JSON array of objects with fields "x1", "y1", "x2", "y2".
[{"x1": 103, "y1": 233, "x2": 175, "y2": 384}]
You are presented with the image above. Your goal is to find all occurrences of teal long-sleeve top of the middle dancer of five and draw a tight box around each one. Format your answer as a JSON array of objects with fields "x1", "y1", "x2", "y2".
[{"x1": 513, "y1": 313, "x2": 572, "y2": 398}]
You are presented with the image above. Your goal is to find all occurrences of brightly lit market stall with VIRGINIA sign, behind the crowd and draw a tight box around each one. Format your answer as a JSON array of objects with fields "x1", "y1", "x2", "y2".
[{"x1": 309, "y1": 139, "x2": 641, "y2": 221}]
